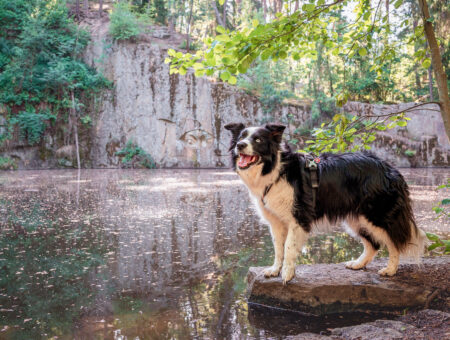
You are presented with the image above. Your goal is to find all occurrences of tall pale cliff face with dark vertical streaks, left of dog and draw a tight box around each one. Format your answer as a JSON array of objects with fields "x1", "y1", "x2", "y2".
[{"x1": 86, "y1": 23, "x2": 309, "y2": 168}]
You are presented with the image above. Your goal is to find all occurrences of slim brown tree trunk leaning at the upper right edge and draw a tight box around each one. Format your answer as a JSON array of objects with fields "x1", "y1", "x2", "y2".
[{"x1": 419, "y1": 0, "x2": 450, "y2": 139}]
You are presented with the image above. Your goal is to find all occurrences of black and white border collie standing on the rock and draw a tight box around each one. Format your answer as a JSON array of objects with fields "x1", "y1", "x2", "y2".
[{"x1": 225, "y1": 123, "x2": 426, "y2": 284}]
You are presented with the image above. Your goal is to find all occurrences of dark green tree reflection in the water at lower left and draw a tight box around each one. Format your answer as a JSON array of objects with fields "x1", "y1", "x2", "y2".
[{"x1": 0, "y1": 200, "x2": 106, "y2": 339}]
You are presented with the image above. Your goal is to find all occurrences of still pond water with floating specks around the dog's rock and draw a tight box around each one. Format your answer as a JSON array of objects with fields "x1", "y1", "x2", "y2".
[{"x1": 0, "y1": 169, "x2": 450, "y2": 339}]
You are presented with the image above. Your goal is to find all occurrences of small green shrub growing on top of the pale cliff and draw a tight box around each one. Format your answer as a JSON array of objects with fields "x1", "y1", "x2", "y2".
[{"x1": 109, "y1": 2, "x2": 141, "y2": 40}]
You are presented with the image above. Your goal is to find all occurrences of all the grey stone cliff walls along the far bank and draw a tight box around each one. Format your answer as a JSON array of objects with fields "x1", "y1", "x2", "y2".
[{"x1": 0, "y1": 17, "x2": 450, "y2": 169}]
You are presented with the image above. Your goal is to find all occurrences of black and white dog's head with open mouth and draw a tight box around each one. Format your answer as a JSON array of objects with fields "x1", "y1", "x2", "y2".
[{"x1": 225, "y1": 123, "x2": 286, "y2": 175}]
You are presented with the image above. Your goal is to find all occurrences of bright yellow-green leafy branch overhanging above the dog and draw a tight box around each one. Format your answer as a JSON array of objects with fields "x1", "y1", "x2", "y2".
[{"x1": 166, "y1": 0, "x2": 429, "y2": 84}]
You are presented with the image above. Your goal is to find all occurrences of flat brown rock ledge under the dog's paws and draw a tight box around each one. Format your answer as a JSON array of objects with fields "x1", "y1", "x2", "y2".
[{"x1": 247, "y1": 256, "x2": 450, "y2": 316}]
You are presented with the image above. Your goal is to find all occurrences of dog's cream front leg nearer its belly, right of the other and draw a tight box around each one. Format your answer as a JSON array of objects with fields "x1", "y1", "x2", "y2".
[{"x1": 281, "y1": 223, "x2": 308, "y2": 284}]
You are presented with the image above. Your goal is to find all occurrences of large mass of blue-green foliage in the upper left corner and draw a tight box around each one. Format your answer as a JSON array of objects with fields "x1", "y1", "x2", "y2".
[{"x1": 0, "y1": 0, "x2": 108, "y2": 144}]
